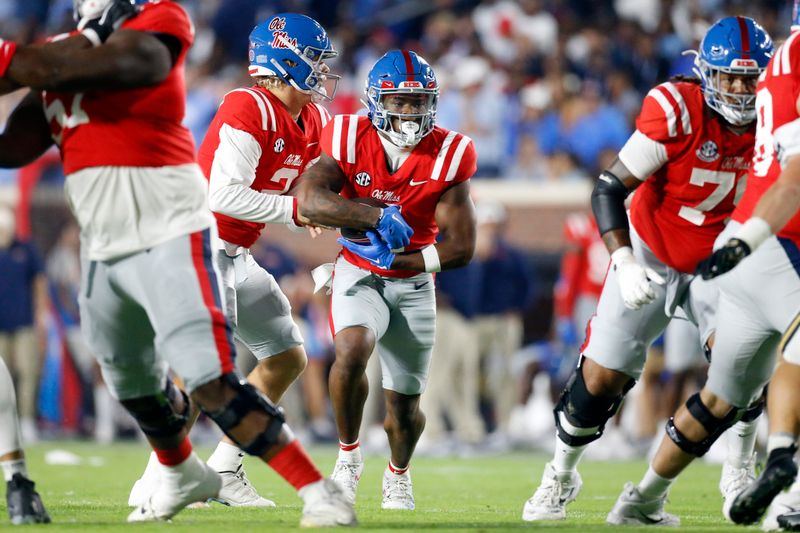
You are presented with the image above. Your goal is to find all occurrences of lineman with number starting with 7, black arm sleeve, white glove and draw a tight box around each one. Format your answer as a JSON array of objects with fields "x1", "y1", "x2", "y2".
[{"x1": 523, "y1": 17, "x2": 772, "y2": 524}]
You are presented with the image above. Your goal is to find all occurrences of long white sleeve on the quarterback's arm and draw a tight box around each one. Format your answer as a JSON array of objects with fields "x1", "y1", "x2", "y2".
[{"x1": 208, "y1": 124, "x2": 294, "y2": 224}]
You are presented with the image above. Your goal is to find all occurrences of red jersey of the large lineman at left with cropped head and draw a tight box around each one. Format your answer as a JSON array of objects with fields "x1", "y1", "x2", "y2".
[{"x1": 43, "y1": 0, "x2": 194, "y2": 174}]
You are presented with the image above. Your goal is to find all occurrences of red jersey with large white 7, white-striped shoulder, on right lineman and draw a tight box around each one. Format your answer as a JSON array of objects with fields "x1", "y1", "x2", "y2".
[{"x1": 630, "y1": 82, "x2": 755, "y2": 273}]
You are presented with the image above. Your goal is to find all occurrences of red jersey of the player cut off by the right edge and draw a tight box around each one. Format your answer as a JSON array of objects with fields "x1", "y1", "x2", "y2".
[{"x1": 733, "y1": 32, "x2": 800, "y2": 245}]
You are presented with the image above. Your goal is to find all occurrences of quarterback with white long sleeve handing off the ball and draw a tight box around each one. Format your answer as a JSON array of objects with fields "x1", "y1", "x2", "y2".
[{"x1": 128, "y1": 13, "x2": 352, "y2": 513}]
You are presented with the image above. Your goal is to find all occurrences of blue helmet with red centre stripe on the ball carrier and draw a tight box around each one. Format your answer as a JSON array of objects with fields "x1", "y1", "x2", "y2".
[{"x1": 364, "y1": 50, "x2": 439, "y2": 147}]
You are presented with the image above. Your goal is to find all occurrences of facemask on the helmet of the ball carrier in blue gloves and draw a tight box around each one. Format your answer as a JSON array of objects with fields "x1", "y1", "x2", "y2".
[{"x1": 367, "y1": 88, "x2": 439, "y2": 148}]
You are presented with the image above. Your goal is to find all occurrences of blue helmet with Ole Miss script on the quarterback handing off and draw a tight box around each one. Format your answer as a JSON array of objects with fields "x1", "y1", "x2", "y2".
[{"x1": 248, "y1": 13, "x2": 340, "y2": 100}]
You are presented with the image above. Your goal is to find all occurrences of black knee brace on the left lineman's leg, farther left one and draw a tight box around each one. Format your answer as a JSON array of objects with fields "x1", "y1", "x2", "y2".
[{"x1": 121, "y1": 378, "x2": 191, "y2": 439}]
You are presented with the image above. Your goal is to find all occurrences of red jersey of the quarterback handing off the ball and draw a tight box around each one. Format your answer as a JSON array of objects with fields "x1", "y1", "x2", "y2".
[{"x1": 197, "y1": 86, "x2": 330, "y2": 248}]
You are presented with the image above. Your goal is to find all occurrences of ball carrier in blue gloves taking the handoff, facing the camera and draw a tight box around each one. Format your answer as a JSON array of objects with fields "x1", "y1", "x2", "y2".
[{"x1": 297, "y1": 50, "x2": 476, "y2": 510}]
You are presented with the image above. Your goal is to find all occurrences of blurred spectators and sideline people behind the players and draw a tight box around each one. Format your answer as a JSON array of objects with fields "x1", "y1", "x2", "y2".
[{"x1": 0, "y1": 0, "x2": 780, "y2": 453}]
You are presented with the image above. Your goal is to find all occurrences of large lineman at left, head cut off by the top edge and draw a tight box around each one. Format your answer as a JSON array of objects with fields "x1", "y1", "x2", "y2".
[{"x1": 0, "y1": 0, "x2": 355, "y2": 526}]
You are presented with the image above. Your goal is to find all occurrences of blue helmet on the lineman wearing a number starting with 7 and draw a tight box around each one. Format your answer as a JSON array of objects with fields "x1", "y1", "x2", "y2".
[{"x1": 694, "y1": 16, "x2": 773, "y2": 126}]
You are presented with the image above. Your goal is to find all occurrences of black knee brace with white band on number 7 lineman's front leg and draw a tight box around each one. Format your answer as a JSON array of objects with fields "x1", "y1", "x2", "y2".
[{"x1": 553, "y1": 365, "x2": 636, "y2": 446}]
